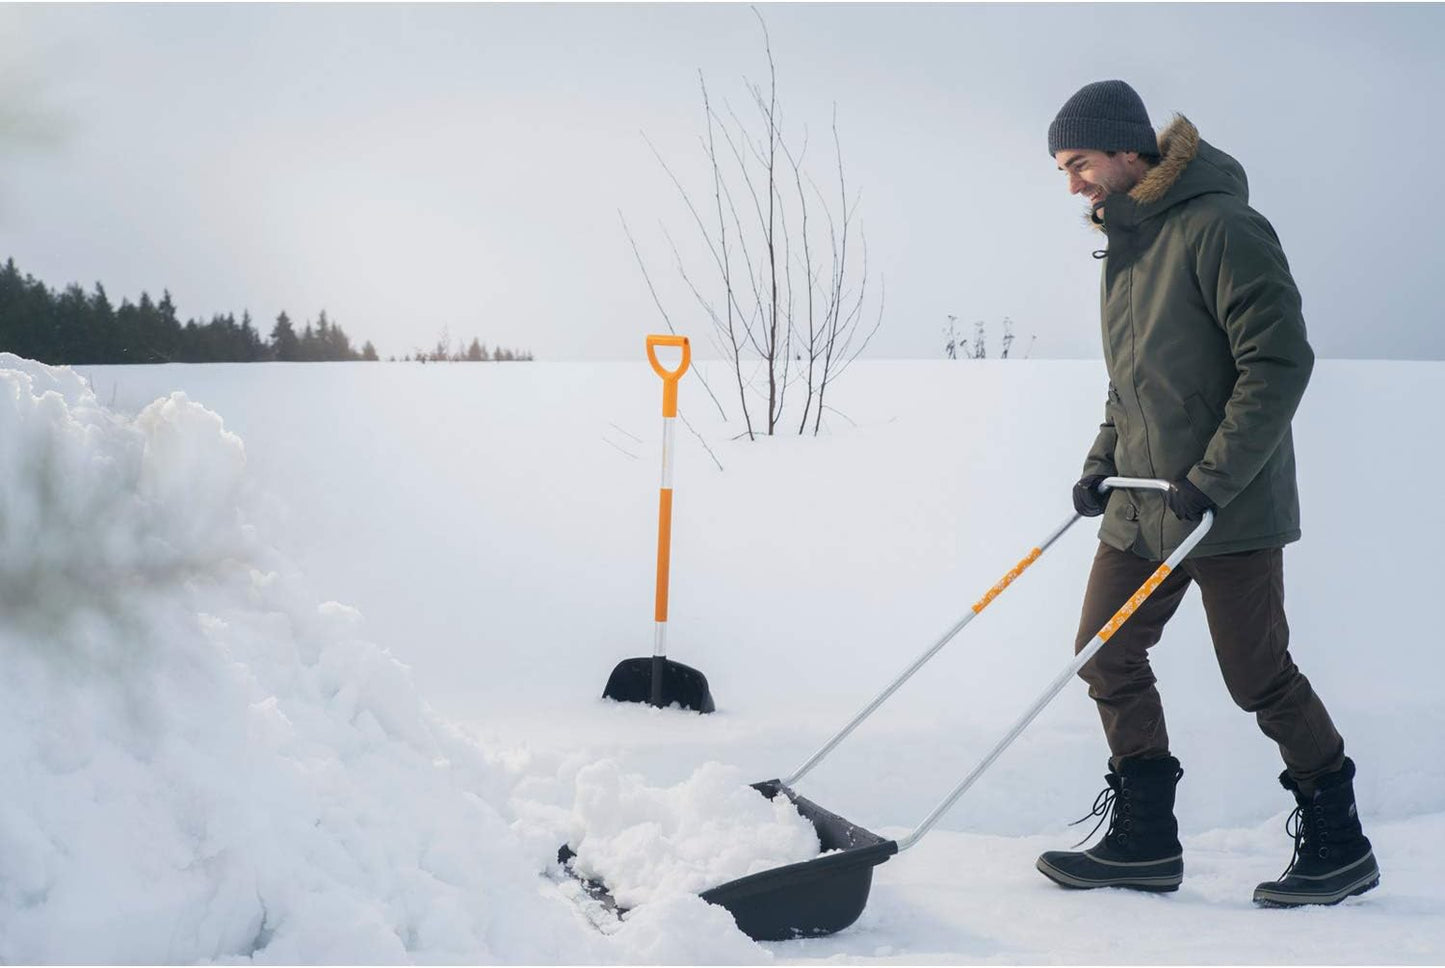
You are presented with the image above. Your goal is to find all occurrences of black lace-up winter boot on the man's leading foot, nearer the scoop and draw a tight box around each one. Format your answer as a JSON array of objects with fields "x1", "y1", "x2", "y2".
[{"x1": 1035, "y1": 756, "x2": 1183, "y2": 891}]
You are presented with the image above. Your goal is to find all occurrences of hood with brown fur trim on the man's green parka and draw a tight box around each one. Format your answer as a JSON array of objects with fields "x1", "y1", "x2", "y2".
[{"x1": 1090, "y1": 114, "x2": 1250, "y2": 227}]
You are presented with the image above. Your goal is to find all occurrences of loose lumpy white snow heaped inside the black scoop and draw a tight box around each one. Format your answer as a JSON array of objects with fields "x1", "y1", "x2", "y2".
[{"x1": 569, "y1": 760, "x2": 818, "y2": 907}]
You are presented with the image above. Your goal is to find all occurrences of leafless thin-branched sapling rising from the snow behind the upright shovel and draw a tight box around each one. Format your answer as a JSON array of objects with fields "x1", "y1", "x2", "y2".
[{"x1": 623, "y1": 7, "x2": 883, "y2": 439}]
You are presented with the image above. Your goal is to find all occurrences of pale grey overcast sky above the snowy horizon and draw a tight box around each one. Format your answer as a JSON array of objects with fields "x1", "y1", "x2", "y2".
[{"x1": 0, "y1": 4, "x2": 1445, "y2": 360}]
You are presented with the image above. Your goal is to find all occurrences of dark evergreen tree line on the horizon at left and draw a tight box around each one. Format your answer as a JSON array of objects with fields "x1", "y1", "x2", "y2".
[{"x1": 0, "y1": 259, "x2": 532, "y2": 366}]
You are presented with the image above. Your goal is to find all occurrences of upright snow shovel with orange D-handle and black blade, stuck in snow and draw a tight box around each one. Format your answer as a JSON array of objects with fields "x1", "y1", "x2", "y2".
[{"x1": 603, "y1": 335, "x2": 715, "y2": 712}]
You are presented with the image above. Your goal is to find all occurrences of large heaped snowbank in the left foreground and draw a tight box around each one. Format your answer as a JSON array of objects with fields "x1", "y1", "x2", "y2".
[{"x1": 0, "y1": 355, "x2": 763, "y2": 964}]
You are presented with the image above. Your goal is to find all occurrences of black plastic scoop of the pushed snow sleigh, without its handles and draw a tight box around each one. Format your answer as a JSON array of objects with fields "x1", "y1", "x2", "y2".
[{"x1": 556, "y1": 780, "x2": 899, "y2": 941}]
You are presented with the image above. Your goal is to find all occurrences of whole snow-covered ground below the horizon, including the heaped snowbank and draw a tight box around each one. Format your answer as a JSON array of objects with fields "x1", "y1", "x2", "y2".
[{"x1": 0, "y1": 353, "x2": 1445, "y2": 964}]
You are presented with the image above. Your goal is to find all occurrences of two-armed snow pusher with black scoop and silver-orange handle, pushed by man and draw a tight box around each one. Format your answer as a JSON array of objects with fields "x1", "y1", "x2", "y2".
[{"x1": 558, "y1": 477, "x2": 1214, "y2": 941}]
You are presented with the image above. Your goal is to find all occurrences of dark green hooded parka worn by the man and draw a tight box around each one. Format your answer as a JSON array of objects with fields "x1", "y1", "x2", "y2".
[{"x1": 1084, "y1": 116, "x2": 1315, "y2": 561}]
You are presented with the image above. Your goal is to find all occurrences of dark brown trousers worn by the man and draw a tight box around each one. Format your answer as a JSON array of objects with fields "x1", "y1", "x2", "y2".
[{"x1": 1074, "y1": 543, "x2": 1345, "y2": 786}]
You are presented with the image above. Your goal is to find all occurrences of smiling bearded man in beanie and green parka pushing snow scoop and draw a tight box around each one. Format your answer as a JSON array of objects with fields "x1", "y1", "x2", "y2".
[{"x1": 1038, "y1": 81, "x2": 1380, "y2": 906}]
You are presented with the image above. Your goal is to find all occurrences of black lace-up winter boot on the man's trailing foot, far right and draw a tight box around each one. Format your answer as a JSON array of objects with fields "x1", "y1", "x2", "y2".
[{"x1": 1254, "y1": 757, "x2": 1380, "y2": 907}]
